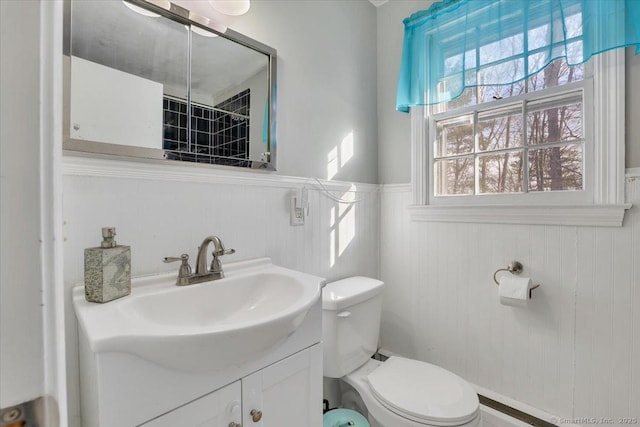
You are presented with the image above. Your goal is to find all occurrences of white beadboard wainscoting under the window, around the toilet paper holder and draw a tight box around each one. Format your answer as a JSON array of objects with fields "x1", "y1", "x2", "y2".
[{"x1": 380, "y1": 176, "x2": 640, "y2": 424}]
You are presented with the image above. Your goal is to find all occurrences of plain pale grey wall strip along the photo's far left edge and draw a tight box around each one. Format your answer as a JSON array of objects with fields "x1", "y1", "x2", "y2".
[{"x1": 0, "y1": 1, "x2": 44, "y2": 408}]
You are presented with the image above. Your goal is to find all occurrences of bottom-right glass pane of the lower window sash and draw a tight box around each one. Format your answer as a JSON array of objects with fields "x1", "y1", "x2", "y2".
[{"x1": 529, "y1": 144, "x2": 583, "y2": 191}]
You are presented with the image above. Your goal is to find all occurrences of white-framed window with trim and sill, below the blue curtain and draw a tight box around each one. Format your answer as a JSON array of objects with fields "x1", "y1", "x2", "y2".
[{"x1": 410, "y1": 50, "x2": 630, "y2": 226}]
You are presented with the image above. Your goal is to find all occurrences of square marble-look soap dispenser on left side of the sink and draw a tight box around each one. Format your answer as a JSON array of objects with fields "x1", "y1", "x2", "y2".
[{"x1": 84, "y1": 227, "x2": 131, "y2": 303}]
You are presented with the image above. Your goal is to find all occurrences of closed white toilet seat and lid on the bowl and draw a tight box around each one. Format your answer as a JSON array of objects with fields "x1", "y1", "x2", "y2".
[{"x1": 367, "y1": 357, "x2": 479, "y2": 425}]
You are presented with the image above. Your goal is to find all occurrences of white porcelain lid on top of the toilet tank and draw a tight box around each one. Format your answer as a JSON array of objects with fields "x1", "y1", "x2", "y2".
[{"x1": 322, "y1": 276, "x2": 384, "y2": 310}]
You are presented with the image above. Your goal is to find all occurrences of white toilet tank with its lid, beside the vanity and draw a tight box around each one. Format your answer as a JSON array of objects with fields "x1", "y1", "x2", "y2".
[{"x1": 322, "y1": 276, "x2": 384, "y2": 378}]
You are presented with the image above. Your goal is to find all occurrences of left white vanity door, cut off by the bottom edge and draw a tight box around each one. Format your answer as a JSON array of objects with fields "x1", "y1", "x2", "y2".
[{"x1": 141, "y1": 381, "x2": 241, "y2": 427}]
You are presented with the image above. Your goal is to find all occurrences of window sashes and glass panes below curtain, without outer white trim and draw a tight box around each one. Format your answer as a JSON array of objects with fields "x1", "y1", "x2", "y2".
[{"x1": 429, "y1": 60, "x2": 592, "y2": 197}]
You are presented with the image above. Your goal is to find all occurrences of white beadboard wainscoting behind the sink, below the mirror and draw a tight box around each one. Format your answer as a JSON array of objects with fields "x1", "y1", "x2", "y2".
[{"x1": 63, "y1": 157, "x2": 379, "y2": 427}]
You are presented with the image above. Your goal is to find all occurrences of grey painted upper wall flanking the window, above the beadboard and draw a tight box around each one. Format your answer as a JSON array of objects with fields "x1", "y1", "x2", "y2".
[{"x1": 378, "y1": 0, "x2": 640, "y2": 184}]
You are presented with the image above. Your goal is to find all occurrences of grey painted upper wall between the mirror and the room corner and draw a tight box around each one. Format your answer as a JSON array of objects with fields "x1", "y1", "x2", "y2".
[{"x1": 229, "y1": 0, "x2": 378, "y2": 183}]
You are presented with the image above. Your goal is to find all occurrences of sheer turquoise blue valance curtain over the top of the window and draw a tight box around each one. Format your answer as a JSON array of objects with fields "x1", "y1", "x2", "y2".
[{"x1": 396, "y1": 0, "x2": 640, "y2": 112}]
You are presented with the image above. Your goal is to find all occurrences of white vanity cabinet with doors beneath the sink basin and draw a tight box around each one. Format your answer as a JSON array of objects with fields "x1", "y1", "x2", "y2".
[{"x1": 74, "y1": 276, "x2": 322, "y2": 427}]
